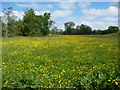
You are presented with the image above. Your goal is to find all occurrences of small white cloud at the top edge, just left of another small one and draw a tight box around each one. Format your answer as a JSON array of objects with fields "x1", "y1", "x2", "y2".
[{"x1": 57, "y1": 2, "x2": 76, "y2": 9}]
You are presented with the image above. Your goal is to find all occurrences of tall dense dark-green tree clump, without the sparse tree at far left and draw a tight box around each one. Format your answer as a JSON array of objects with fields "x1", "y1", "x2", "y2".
[{"x1": 22, "y1": 9, "x2": 53, "y2": 36}]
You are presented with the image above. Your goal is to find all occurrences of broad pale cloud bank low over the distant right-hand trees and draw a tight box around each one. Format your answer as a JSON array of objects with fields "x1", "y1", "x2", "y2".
[{"x1": 66, "y1": 8, "x2": 118, "y2": 30}]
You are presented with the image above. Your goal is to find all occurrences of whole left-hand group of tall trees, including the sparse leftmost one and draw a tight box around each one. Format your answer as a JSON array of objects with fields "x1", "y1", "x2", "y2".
[{"x1": 2, "y1": 7, "x2": 54, "y2": 37}]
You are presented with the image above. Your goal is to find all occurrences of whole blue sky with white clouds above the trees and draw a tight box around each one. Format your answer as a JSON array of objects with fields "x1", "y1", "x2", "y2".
[{"x1": 1, "y1": 0, "x2": 118, "y2": 30}]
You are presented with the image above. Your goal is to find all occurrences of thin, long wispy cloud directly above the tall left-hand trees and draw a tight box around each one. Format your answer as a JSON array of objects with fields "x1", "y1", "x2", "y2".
[{"x1": 16, "y1": 3, "x2": 53, "y2": 9}]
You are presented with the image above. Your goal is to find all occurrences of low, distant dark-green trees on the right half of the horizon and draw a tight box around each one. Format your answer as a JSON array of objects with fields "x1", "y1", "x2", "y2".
[{"x1": 63, "y1": 22, "x2": 119, "y2": 35}]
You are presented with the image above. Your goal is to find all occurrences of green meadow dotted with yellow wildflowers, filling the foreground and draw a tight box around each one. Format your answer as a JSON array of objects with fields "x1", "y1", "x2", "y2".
[{"x1": 2, "y1": 34, "x2": 120, "y2": 89}]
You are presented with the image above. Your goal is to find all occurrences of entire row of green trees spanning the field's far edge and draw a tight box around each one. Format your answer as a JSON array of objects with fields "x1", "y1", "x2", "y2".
[{"x1": 0, "y1": 7, "x2": 119, "y2": 37}]
